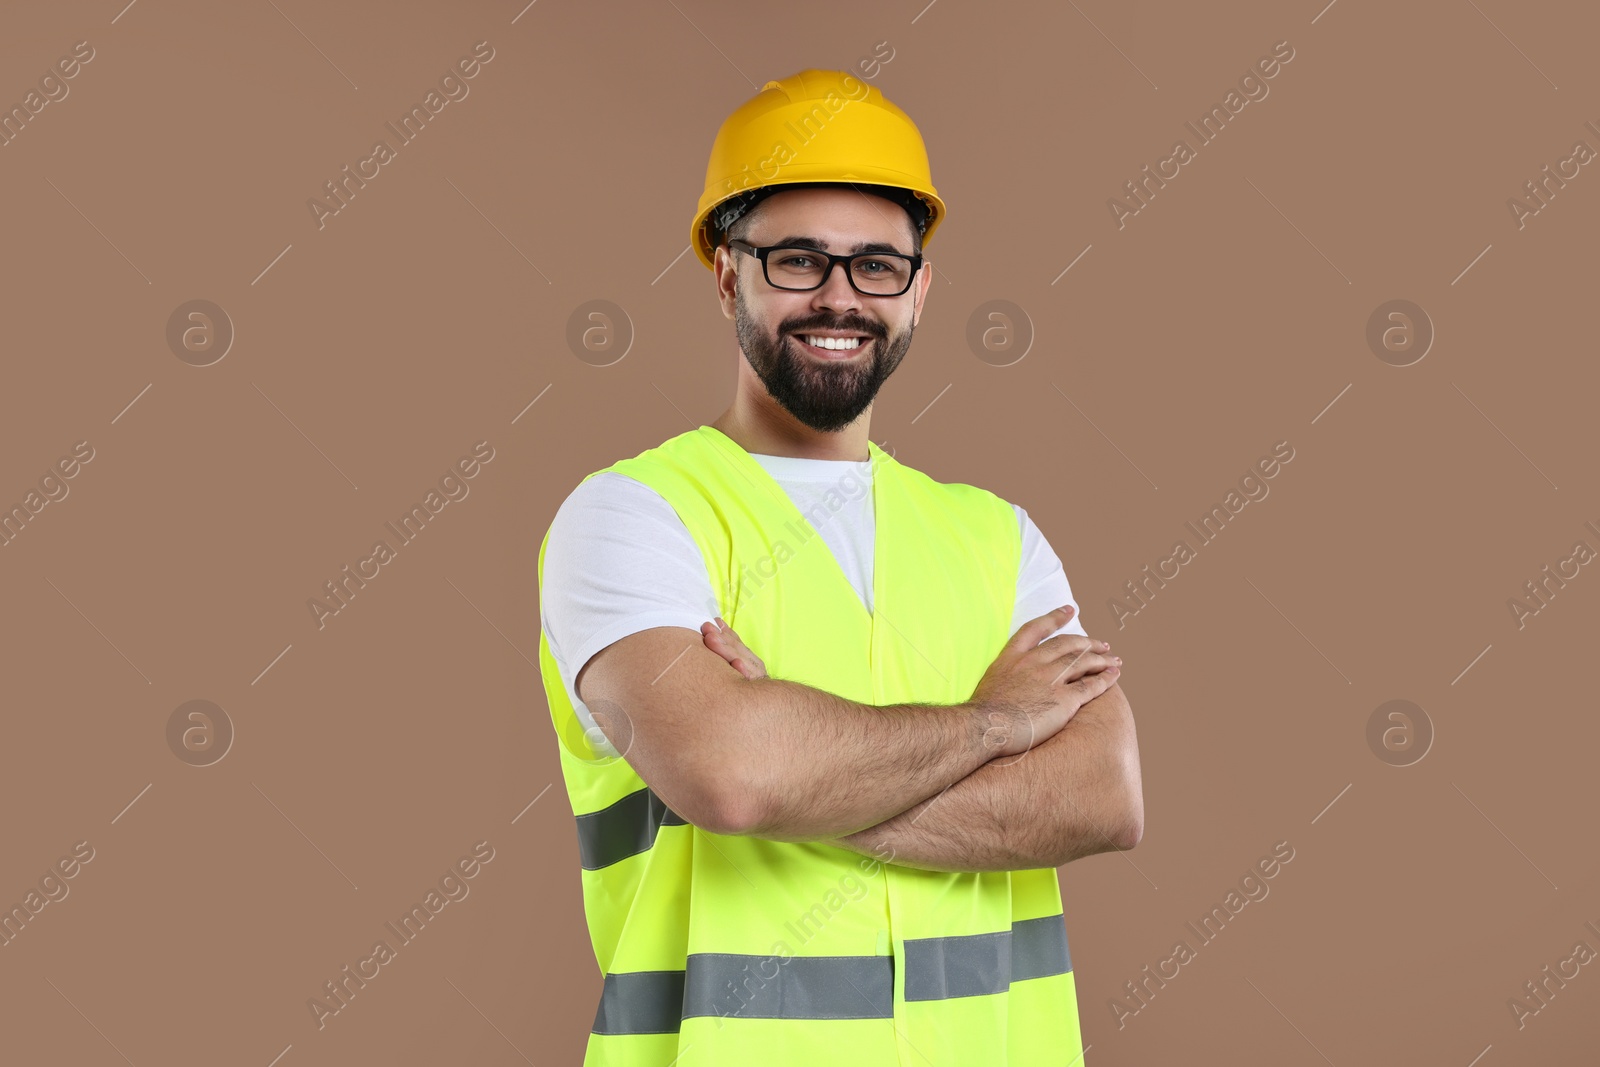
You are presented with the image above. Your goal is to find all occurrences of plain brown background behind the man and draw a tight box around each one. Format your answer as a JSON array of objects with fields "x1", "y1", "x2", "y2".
[{"x1": 0, "y1": 0, "x2": 1600, "y2": 1067}]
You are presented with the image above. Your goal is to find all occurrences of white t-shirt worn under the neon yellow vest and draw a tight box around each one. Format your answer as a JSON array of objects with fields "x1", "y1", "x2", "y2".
[{"x1": 539, "y1": 453, "x2": 1085, "y2": 755}]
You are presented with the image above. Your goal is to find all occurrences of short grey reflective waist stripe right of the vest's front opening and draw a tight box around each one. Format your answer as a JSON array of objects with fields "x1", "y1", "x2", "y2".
[{"x1": 906, "y1": 915, "x2": 1072, "y2": 1000}]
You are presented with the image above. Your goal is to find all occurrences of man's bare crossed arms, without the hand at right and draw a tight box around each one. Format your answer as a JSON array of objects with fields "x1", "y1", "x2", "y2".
[{"x1": 576, "y1": 624, "x2": 1144, "y2": 872}]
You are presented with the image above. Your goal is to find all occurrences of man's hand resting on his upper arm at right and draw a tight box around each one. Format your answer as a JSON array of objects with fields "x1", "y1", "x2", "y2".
[{"x1": 971, "y1": 606, "x2": 1122, "y2": 757}]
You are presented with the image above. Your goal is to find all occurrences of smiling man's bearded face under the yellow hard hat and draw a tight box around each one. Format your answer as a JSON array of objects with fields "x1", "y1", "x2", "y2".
[{"x1": 718, "y1": 189, "x2": 928, "y2": 432}]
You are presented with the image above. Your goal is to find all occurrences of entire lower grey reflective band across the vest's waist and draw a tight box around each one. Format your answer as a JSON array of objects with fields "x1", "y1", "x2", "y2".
[{"x1": 594, "y1": 915, "x2": 1072, "y2": 1033}]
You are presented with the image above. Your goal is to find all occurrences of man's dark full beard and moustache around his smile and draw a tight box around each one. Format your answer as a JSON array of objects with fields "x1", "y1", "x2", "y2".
[{"x1": 734, "y1": 286, "x2": 912, "y2": 432}]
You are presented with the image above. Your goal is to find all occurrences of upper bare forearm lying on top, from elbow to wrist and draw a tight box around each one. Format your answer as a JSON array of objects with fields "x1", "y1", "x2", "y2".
[{"x1": 718, "y1": 678, "x2": 995, "y2": 841}]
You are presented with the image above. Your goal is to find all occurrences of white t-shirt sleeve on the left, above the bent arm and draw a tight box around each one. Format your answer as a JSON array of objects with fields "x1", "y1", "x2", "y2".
[{"x1": 539, "y1": 470, "x2": 722, "y2": 704}]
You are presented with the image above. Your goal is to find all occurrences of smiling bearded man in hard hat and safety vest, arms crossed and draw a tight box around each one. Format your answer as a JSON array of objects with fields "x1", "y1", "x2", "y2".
[{"x1": 539, "y1": 70, "x2": 1144, "y2": 1067}]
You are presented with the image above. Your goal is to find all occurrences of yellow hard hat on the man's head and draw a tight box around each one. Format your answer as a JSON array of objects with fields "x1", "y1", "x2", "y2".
[{"x1": 690, "y1": 70, "x2": 944, "y2": 267}]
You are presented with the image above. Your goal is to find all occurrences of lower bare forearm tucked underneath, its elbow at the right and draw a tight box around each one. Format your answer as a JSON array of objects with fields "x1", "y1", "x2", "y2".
[{"x1": 835, "y1": 685, "x2": 1144, "y2": 872}]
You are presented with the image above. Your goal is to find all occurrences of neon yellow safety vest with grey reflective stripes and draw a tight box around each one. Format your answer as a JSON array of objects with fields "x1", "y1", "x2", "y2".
[{"x1": 539, "y1": 426, "x2": 1082, "y2": 1067}]
